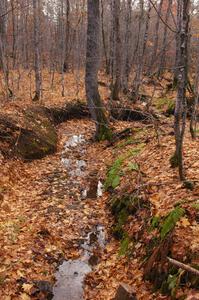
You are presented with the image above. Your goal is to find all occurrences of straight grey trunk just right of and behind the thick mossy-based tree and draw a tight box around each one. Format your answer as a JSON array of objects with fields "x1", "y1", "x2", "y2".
[{"x1": 112, "y1": 0, "x2": 121, "y2": 100}]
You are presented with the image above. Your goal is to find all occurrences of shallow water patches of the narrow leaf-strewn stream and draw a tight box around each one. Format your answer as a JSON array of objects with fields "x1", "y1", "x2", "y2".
[{"x1": 53, "y1": 135, "x2": 106, "y2": 300}]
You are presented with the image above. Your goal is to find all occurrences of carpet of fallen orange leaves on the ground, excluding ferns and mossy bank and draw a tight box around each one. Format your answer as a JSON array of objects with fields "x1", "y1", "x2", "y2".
[{"x1": 0, "y1": 71, "x2": 199, "y2": 300}]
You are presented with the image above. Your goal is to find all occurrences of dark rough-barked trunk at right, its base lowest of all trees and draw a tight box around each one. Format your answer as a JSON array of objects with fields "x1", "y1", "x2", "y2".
[{"x1": 174, "y1": 0, "x2": 190, "y2": 180}]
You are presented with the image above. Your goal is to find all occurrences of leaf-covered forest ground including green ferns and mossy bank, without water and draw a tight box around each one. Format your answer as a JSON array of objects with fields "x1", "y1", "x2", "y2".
[{"x1": 0, "y1": 71, "x2": 199, "y2": 300}]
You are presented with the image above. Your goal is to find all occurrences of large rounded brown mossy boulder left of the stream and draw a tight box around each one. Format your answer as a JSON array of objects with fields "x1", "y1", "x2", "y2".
[{"x1": 0, "y1": 107, "x2": 57, "y2": 160}]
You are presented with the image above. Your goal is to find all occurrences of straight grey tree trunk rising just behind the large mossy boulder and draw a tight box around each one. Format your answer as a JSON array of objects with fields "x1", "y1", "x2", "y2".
[{"x1": 33, "y1": 0, "x2": 41, "y2": 101}]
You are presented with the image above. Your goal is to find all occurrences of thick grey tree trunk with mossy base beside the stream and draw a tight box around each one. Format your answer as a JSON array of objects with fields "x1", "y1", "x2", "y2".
[{"x1": 85, "y1": 0, "x2": 111, "y2": 140}]
